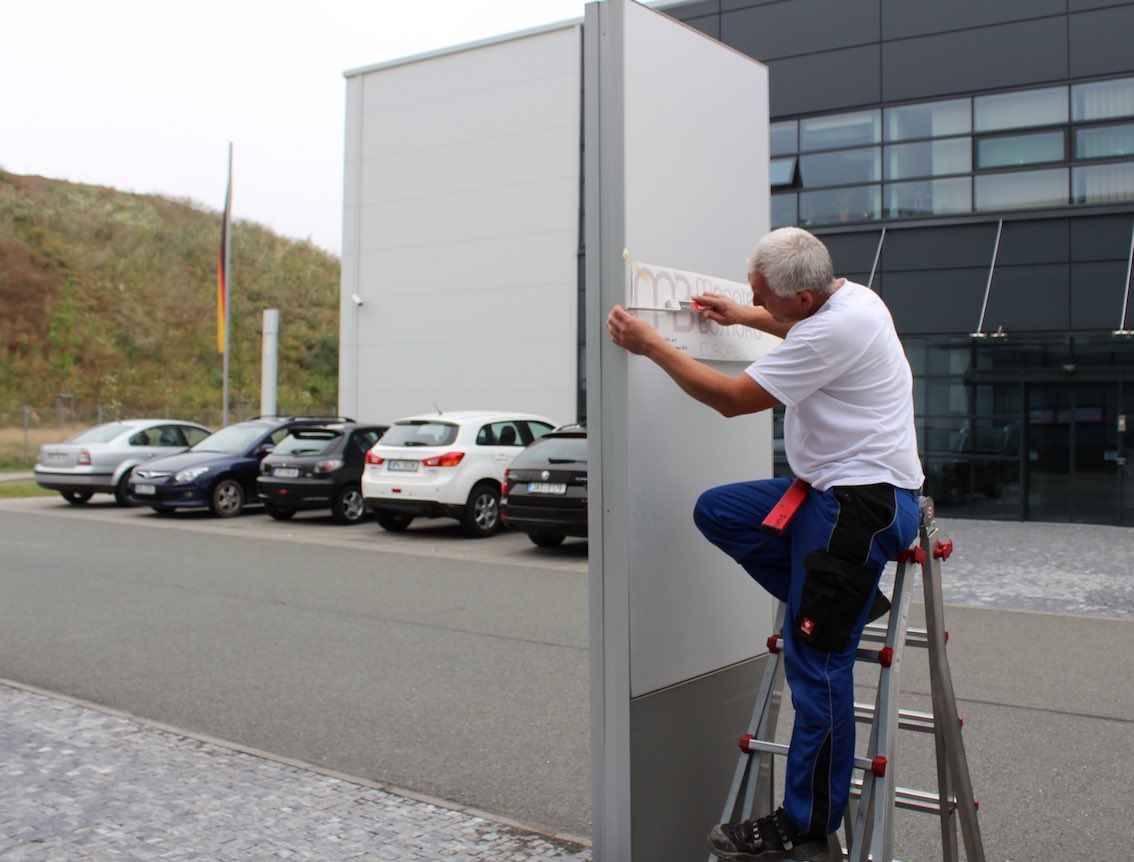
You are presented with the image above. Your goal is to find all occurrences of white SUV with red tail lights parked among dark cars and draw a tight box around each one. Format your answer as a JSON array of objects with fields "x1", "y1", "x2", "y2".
[{"x1": 362, "y1": 411, "x2": 556, "y2": 536}]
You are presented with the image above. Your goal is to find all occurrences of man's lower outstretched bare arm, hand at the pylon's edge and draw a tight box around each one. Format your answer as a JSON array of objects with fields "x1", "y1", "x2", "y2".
[{"x1": 607, "y1": 305, "x2": 779, "y2": 416}]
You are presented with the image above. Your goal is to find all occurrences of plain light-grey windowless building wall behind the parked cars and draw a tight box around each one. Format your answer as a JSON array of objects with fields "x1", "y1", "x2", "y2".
[{"x1": 339, "y1": 25, "x2": 582, "y2": 422}]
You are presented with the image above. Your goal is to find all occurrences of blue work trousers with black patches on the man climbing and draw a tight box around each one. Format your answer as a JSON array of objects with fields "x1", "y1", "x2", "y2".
[{"x1": 694, "y1": 479, "x2": 919, "y2": 835}]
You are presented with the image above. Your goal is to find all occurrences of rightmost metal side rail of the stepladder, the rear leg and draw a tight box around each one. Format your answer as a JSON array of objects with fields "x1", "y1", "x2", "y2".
[{"x1": 922, "y1": 498, "x2": 984, "y2": 862}]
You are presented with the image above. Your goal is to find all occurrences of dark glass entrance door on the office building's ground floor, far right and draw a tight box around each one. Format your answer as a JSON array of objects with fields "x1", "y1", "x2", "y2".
[{"x1": 1025, "y1": 382, "x2": 1134, "y2": 524}]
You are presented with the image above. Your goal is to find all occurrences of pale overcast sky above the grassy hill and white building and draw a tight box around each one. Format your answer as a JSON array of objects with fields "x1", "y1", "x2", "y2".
[{"x1": 0, "y1": 0, "x2": 585, "y2": 254}]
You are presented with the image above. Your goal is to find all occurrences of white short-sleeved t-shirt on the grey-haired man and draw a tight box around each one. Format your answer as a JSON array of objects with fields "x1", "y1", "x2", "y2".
[{"x1": 747, "y1": 281, "x2": 924, "y2": 491}]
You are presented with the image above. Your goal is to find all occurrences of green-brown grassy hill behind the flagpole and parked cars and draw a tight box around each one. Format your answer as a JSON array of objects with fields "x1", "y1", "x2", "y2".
[{"x1": 0, "y1": 170, "x2": 339, "y2": 425}]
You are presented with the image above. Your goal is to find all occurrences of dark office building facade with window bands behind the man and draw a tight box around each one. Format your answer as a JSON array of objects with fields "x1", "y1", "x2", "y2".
[{"x1": 662, "y1": 0, "x2": 1134, "y2": 526}]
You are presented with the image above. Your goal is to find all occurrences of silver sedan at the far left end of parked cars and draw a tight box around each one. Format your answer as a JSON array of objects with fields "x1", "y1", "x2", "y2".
[{"x1": 35, "y1": 419, "x2": 210, "y2": 506}]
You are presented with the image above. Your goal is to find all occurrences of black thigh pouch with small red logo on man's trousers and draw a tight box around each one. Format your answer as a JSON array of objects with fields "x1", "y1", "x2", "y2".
[{"x1": 795, "y1": 551, "x2": 878, "y2": 652}]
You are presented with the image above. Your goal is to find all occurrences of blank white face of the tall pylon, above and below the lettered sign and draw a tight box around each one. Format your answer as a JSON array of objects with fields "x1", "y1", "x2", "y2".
[{"x1": 625, "y1": 3, "x2": 775, "y2": 696}]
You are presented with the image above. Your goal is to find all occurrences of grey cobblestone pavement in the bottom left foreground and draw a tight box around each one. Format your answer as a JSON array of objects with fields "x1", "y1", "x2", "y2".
[{"x1": 0, "y1": 685, "x2": 591, "y2": 862}]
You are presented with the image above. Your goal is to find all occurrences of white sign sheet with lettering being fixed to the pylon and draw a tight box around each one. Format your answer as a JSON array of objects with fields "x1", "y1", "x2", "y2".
[{"x1": 626, "y1": 255, "x2": 780, "y2": 363}]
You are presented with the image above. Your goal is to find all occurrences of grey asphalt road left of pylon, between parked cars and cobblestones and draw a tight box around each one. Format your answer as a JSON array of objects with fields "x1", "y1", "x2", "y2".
[{"x1": 0, "y1": 497, "x2": 591, "y2": 836}]
